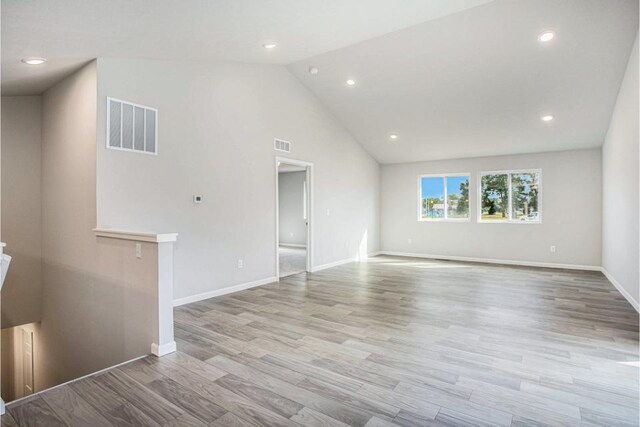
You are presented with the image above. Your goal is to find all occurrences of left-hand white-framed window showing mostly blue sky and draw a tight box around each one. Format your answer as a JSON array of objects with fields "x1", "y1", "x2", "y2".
[{"x1": 418, "y1": 174, "x2": 469, "y2": 221}]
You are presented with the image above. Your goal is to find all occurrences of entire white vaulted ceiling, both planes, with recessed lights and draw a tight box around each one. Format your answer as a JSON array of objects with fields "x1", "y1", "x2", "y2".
[{"x1": 2, "y1": 0, "x2": 638, "y2": 163}]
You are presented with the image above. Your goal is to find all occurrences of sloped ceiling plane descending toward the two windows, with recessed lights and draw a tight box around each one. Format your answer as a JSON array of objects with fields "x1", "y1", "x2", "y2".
[{"x1": 289, "y1": 0, "x2": 638, "y2": 163}]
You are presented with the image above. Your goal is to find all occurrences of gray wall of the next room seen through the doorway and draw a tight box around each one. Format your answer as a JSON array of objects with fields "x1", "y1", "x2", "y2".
[{"x1": 278, "y1": 172, "x2": 307, "y2": 245}]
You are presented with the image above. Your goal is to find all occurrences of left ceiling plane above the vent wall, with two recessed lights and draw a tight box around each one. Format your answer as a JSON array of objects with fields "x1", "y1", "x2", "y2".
[{"x1": 2, "y1": 0, "x2": 490, "y2": 95}]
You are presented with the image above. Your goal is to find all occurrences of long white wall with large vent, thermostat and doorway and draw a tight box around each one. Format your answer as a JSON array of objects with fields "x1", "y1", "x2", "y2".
[{"x1": 92, "y1": 58, "x2": 380, "y2": 299}]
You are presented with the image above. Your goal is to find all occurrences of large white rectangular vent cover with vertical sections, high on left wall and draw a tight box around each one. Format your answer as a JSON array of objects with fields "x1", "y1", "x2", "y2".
[{"x1": 107, "y1": 98, "x2": 158, "y2": 154}]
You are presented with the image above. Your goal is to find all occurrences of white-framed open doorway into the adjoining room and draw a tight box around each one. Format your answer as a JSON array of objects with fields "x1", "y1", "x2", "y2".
[{"x1": 276, "y1": 157, "x2": 313, "y2": 280}]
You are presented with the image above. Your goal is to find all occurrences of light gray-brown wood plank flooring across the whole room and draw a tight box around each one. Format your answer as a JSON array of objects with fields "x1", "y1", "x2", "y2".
[{"x1": 2, "y1": 257, "x2": 639, "y2": 427}]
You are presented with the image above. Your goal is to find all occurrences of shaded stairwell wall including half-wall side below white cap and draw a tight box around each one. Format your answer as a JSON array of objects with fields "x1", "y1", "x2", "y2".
[{"x1": 34, "y1": 62, "x2": 157, "y2": 389}]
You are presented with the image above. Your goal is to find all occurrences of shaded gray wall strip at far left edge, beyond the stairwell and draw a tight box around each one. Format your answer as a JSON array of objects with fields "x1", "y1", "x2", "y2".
[{"x1": 2, "y1": 96, "x2": 42, "y2": 328}]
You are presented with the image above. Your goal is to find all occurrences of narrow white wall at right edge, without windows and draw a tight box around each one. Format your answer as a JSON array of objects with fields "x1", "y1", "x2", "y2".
[{"x1": 602, "y1": 32, "x2": 640, "y2": 310}]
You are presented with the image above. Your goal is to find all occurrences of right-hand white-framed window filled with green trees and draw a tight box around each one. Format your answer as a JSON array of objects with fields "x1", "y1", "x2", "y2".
[{"x1": 478, "y1": 170, "x2": 542, "y2": 224}]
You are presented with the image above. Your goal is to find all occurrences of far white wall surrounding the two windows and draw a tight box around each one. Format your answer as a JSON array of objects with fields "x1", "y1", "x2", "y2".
[{"x1": 382, "y1": 149, "x2": 602, "y2": 267}]
